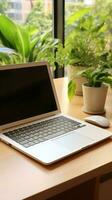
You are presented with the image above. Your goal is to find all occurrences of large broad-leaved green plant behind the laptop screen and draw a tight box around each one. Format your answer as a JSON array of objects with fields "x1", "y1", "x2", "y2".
[{"x1": 0, "y1": 15, "x2": 59, "y2": 66}]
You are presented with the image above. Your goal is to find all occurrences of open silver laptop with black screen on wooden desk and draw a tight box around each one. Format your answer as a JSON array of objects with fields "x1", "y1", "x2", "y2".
[{"x1": 0, "y1": 62, "x2": 111, "y2": 165}]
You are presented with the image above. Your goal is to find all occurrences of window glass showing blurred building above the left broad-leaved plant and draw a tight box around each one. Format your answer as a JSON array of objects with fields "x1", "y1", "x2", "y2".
[{"x1": 3, "y1": 0, "x2": 52, "y2": 31}]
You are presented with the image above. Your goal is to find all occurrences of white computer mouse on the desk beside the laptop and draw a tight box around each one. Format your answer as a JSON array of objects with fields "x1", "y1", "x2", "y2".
[{"x1": 85, "y1": 115, "x2": 110, "y2": 128}]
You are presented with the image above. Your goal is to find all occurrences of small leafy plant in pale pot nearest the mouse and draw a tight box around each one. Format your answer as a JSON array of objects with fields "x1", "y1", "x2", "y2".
[{"x1": 81, "y1": 65, "x2": 112, "y2": 114}]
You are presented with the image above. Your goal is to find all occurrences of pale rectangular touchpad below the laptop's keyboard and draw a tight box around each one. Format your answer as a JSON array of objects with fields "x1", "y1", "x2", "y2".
[{"x1": 52, "y1": 133, "x2": 93, "y2": 151}]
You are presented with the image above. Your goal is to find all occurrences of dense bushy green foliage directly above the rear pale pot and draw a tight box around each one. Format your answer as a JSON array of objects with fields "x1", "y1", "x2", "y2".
[{"x1": 66, "y1": 32, "x2": 98, "y2": 67}]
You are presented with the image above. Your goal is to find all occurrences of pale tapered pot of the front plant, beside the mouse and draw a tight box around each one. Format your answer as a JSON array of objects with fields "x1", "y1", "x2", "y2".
[{"x1": 82, "y1": 84, "x2": 108, "y2": 114}]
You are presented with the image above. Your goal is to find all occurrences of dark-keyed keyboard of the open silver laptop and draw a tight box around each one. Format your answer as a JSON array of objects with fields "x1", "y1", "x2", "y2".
[{"x1": 4, "y1": 116, "x2": 85, "y2": 148}]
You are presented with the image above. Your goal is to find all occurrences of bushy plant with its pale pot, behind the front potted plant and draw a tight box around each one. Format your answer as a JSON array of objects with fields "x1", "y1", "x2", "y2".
[{"x1": 67, "y1": 32, "x2": 100, "y2": 95}]
